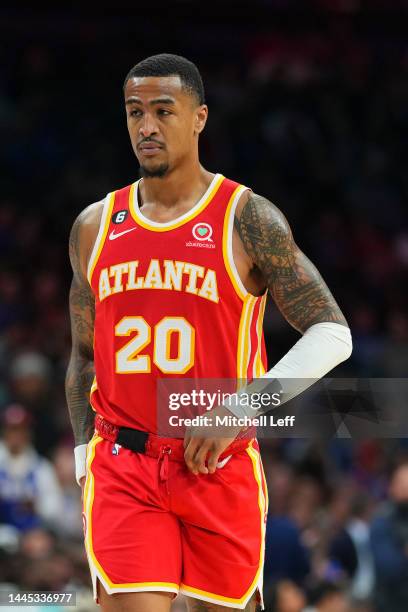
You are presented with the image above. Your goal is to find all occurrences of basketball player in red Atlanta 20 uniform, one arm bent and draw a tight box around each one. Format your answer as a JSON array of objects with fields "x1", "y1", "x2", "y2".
[{"x1": 66, "y1": 54, "x2": 351, "y2": 612}]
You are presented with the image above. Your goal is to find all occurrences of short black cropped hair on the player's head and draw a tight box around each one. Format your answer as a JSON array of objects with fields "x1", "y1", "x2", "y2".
[{"x1": 123, "y1": 53, "x2": 205, "y2": 104}]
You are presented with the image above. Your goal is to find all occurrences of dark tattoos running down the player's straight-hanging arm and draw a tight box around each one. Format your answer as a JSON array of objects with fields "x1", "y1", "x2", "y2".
[{"x1": 65, "y1": 215, "x2": 95, "y2": 444}]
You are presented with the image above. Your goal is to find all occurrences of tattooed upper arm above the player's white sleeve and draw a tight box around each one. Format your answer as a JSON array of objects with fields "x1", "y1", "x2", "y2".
[{"x1": 235, "y1": 194, "x2": 347, "y2": 332}]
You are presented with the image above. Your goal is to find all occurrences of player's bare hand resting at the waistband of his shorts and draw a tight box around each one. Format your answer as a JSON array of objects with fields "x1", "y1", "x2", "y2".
[{"x1": 184, "y1": 406, "x2": 242, "y2": 475}]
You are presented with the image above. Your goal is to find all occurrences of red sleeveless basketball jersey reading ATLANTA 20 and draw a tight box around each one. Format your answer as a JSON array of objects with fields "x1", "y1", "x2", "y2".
[{"x1": 88, "y1": 174, "x2": 266, "y2": 433}]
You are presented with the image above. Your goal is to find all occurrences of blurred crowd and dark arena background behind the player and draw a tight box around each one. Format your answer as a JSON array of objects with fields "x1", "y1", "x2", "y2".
[{"x1": 0, "y1": 2, "x2": 408, "y2": 612}]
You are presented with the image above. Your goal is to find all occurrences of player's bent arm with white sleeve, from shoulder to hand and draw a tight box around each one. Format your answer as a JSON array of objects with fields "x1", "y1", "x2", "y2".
[{"x1": 185, "y1": 193, "x2": 352, "y2": 474}]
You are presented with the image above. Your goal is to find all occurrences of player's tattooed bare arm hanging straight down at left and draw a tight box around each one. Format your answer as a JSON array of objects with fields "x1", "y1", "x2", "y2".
[{"x1": 65, "y1": 202, "x2": 102, "y2": 486}]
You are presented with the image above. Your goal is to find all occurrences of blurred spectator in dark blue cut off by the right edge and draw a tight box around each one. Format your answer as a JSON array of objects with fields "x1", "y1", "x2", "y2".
[{"x1": 371, "y1": 457, "x2": 408, "y2": 612}]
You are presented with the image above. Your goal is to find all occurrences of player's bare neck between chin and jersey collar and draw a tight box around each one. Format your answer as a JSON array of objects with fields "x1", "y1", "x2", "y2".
[{"x1": 139, "y1": 159, "x2": 214, "y2": 208}]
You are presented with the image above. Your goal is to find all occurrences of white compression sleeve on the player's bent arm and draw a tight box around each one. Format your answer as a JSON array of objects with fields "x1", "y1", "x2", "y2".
[{"x1": 224, "y1": 322, "x2": 353, "y2": 417}]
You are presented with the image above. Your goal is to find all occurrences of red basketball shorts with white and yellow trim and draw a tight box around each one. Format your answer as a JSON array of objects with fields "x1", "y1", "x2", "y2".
[{"x1": 84, "y1": 434, "x2": 267, "y2": 609}]
